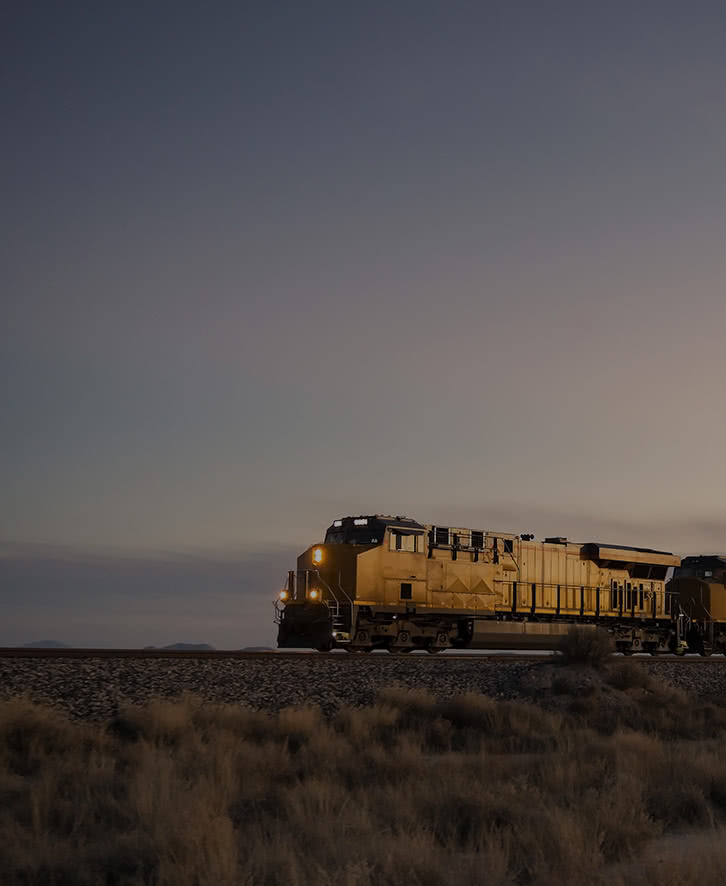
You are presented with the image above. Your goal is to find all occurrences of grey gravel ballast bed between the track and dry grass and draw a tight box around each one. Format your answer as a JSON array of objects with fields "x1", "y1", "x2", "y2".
[{"x1": 0, "y1": 654, "x2": 726, "y2": 720}]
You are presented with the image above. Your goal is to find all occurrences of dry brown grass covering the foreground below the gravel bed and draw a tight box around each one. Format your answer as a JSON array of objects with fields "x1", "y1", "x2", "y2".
[{"x1": 0, "y1": 670, "x2": 726, "y2": 886}]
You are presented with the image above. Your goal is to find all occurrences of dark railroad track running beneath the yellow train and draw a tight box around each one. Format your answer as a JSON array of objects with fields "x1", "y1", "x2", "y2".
[{"x1": 0, "y1": 646, "x2": 726, "y2": 665}]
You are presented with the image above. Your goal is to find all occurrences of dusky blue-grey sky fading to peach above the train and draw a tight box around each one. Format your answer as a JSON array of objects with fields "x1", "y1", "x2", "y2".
[{"x1": 0, "y1": 0, "x2": 726, "y2": 648}]
